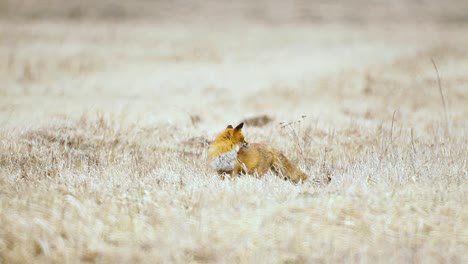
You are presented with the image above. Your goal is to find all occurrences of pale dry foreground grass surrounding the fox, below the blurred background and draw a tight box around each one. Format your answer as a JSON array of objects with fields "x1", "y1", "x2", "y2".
[{"x1": 0, "y1": 111, "x2": 468, "y2": 262}]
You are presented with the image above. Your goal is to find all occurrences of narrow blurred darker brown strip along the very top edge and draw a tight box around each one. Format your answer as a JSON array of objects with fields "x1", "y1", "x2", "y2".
[{"x1": 0, "y1": 0, "x2": 468, "y2": 23}]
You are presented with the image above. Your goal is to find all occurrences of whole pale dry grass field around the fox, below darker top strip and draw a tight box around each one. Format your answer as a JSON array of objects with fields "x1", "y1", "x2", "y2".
[{"x1": 0, "y1": 1, "x2": 468, "y2": 263}]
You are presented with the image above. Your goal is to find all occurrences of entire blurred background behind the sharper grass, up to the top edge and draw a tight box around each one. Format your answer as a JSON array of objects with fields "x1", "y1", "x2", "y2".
[{"x1": 0, "y1": 0, "x2": 468, "y2": 126}]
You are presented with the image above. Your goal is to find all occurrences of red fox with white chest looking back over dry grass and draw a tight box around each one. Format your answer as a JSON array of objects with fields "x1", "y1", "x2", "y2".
[{"x1": 208, "y1": 123, "x2": 308, "y2": 183}]
